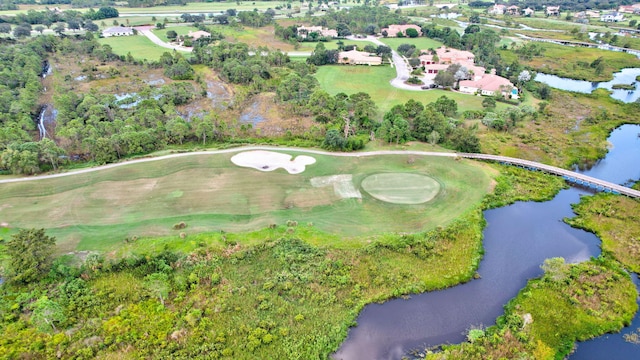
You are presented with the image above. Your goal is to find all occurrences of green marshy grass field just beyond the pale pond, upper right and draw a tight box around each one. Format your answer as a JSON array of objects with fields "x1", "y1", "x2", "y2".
[{"x1": 500, "y1": 43, "x2": 640, "y2": 81}]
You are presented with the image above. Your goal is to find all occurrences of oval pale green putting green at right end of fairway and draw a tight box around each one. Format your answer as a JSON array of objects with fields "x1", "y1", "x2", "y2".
[{"x1": 361, "y1": 173, "x2": 440, "y2": 205}]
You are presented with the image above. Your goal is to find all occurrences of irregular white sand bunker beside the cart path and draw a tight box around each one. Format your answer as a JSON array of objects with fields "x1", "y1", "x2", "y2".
[{"x1": 231, "y1": 150, "x2": 316, "y2": 174}]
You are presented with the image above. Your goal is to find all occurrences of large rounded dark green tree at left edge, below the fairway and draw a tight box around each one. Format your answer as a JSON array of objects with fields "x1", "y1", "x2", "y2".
[{"x1": 6, "y1": 229, "x2": 56, "y2": 284}]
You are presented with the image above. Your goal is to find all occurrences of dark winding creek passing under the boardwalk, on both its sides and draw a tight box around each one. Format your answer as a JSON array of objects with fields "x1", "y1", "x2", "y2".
[{"x1": 334, "y1": 125, "x2": 640, "y2": 359}]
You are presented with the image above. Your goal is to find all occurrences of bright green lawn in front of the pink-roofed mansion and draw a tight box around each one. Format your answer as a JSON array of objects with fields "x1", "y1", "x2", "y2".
[{"x1": 316, "y1": 65, "x2": 507, "y2": 113}]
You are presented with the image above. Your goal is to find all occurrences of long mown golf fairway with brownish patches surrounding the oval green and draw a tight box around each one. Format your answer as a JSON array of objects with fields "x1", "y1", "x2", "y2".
[{"x1": 0, "y1": 149, "x2": 490, "y2": 251}]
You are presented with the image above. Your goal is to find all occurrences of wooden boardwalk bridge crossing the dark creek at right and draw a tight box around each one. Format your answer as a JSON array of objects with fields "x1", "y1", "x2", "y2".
[{"x1": 458, "y1": 153, "x2": 640, "y2": 198}]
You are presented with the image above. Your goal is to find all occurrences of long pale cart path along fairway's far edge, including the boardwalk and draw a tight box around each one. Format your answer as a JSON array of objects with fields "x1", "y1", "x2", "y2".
[{"x1": 0, "y1": 146, "x2": 640, "y2": 198}]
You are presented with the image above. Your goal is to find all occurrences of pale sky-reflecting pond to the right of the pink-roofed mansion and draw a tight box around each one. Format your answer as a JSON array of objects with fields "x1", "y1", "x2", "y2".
[{"x1": 535, "y1": 68, "x2": 640, "y2": 102}]
